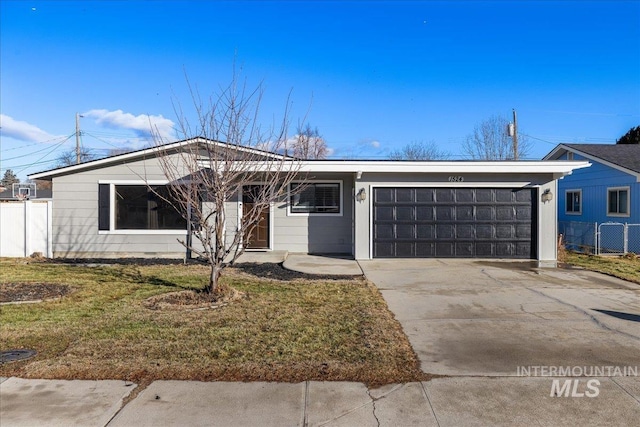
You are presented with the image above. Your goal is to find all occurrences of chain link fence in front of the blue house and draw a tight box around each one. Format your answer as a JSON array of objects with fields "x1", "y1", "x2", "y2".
[{"x1": 558, "y1": 221, "x2": 640, "y2": 255}]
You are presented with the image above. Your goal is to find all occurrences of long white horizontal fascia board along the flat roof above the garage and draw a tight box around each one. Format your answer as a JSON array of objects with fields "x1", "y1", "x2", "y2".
[{"x1": 221, "y1": 161, "x2": 591, "y2": 176}]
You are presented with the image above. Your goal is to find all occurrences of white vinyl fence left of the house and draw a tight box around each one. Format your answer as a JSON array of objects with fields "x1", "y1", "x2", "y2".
[{"x1": 0, "y1": 200, "x2": 52, "y2": 258}]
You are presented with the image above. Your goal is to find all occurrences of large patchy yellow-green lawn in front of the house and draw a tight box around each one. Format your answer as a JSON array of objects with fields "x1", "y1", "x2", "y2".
[{"x1": 0, "y1": 259, "x2": 424, "y2": 384}]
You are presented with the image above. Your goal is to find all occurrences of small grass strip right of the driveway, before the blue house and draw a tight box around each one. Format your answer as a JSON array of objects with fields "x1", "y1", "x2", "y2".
[{"x1": 563, "y1": 252, "x2": 640, "y2": 284}]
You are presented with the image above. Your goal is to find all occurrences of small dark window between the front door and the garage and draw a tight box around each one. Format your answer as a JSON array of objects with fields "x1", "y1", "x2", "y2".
[{"x1": 289, "y1": 182, "x2": 342, "y2": 215}]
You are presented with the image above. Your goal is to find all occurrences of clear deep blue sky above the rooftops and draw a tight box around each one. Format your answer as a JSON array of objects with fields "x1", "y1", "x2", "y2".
[{"x1": 0, "y1": 0, "x2": 640, "y2": 179}]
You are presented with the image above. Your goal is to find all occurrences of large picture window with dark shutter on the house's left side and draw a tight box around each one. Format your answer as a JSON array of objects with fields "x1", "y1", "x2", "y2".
[{"x1": 98, "y1": 184, "x2": 187, "y2": 231}]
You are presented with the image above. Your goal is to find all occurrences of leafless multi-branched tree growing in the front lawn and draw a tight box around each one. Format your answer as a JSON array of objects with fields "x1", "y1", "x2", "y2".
[{"x1": 154, "y1": 77, "x2": 305, "y2": 299}]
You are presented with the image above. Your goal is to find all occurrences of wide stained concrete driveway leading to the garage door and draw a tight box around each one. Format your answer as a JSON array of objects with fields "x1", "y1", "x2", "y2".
[{"x1": 360, "y1": 259, "x2": 640, "y2": 376}]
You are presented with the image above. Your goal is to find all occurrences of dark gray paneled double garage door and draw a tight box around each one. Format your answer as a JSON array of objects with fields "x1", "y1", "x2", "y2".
[{"x1": 373, "y1": 188, "x2": 537, "y2": 258}]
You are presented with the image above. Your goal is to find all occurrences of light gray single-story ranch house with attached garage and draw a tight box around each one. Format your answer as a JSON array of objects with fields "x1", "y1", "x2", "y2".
[{"x1": 29, "y1": 138, "x2": 589, "y2": 265}]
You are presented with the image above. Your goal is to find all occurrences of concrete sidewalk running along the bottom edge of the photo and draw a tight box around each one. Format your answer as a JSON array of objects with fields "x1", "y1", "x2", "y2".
[{"x1": 0, "y1": 377, "x2": 640, "y2": 427}]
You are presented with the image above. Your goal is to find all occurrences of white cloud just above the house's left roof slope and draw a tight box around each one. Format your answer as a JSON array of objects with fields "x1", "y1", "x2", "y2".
[{"x1": 82, "y1": 109, "x2": 175, "y2": 140}]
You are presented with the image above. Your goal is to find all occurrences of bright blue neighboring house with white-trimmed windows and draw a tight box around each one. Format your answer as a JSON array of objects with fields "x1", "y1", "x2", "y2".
[{"x1": 544, "y1": 144, "x2": 640, "y2": 252}]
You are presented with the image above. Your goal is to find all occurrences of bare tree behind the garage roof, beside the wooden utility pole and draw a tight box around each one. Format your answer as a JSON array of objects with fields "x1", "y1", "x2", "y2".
[{"x1": 462, "y1": 115, "x2": 530, "y2": 160}]
